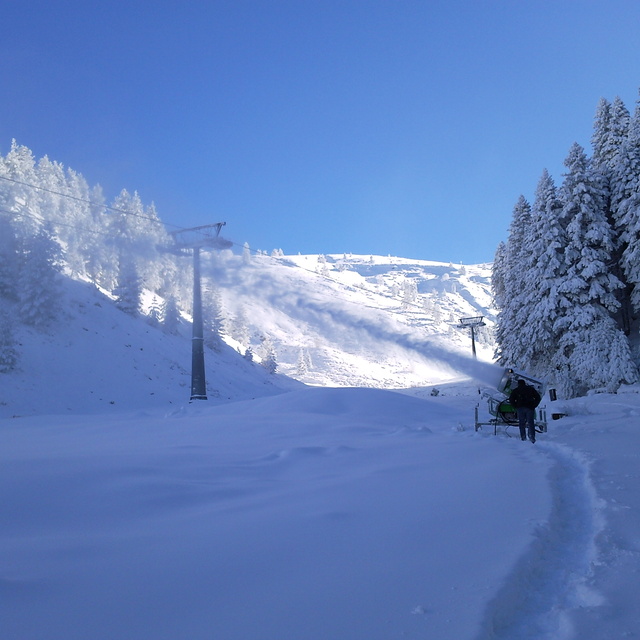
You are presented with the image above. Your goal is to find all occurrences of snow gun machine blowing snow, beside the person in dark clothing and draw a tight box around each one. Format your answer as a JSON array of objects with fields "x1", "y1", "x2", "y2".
[{"x1": 475, "y1": 369, "x2": 547, "y2": 435}]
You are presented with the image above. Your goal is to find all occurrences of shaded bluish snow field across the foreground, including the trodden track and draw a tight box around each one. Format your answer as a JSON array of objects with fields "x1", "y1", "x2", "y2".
[{"x1": 0, "y1": 383, "x2": 640, "y2": 640}]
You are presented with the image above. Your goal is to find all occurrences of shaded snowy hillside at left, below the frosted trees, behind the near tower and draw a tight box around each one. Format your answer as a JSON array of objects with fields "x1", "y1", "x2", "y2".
[{"x1": 0, "y1": 279, "x2": 301, "y2": 417}]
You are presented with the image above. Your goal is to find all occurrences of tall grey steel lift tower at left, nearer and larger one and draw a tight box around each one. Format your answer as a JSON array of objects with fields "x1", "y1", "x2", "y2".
[{"x1": 169, "y1": 222, "x2": 233, "y2": 401}]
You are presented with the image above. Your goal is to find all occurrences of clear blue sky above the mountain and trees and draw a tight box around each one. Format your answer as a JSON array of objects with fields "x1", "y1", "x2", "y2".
[{"x1": 0, "y1": 0, "x2": 640, "y2": 263}]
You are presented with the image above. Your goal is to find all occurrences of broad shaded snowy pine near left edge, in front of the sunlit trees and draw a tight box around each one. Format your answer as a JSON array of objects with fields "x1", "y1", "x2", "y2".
[{"x1": 17, "y1": 224, "x2": 62, "y2": 327}]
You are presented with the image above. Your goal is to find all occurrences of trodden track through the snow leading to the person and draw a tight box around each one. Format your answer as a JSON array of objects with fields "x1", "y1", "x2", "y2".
[{"x1": 477, "y1": 442, "x2": 602, "y2": 640}]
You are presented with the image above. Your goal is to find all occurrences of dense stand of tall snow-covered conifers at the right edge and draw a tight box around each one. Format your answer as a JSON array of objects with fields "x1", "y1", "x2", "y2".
[{"x1": 492, "y1": 93, "x2": 640, "y2": 397}]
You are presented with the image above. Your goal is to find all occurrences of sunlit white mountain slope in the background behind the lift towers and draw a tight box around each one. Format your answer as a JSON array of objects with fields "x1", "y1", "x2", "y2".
[{"x1": 208, "y1": 254, "x2": 495, "y2": 388}]
